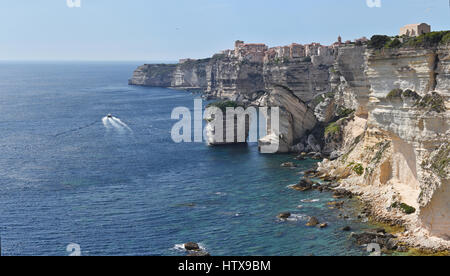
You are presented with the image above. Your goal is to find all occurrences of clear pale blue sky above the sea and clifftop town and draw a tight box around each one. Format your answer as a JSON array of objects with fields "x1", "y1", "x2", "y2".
[{"x1": 0, "y1": 0, "x2": 450, "y2": 61}]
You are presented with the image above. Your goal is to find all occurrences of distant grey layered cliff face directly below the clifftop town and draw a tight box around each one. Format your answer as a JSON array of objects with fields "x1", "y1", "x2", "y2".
[{"x1": 129, "y1": 54, "x2": 334, "y2": 102}]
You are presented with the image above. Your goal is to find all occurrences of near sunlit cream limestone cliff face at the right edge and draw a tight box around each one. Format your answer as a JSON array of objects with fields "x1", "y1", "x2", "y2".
[{"x1": 319, "y1": 47, "x2": 450, "y2": 249}]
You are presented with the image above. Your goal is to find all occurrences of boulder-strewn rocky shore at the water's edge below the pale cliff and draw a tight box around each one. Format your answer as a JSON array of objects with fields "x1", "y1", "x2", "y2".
[{"x1": 286, "y1": 158, "x2": 450, "y2": 256}]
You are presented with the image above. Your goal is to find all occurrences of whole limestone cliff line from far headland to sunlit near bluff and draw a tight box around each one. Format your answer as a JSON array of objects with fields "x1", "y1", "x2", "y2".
[{"x1": 130, "y1": 33, "x2": 450, "y2": 251}]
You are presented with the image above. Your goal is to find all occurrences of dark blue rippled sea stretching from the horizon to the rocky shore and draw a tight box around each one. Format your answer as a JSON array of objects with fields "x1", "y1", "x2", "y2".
[{"x1": 0, "y1": 63, "x2": 365, "y2": 255}]
